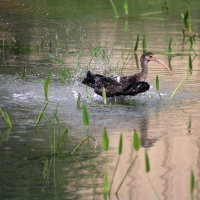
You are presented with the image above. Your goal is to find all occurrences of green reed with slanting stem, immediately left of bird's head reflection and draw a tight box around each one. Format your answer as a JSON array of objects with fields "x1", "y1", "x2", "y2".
[{"x1": 116, "y1": 130, "x2": 140, "y2": 195}]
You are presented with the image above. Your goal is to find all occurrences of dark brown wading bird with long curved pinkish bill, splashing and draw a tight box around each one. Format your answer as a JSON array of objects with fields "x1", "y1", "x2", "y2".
[{"x1": 82, "y1": 52, "x2": 171, "y2": 97}]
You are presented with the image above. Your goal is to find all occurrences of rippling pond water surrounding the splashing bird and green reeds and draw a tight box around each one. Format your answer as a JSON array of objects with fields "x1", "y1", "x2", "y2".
[{"x1": 0, "y1": 0, "x2": 200, "y2": 200}]
